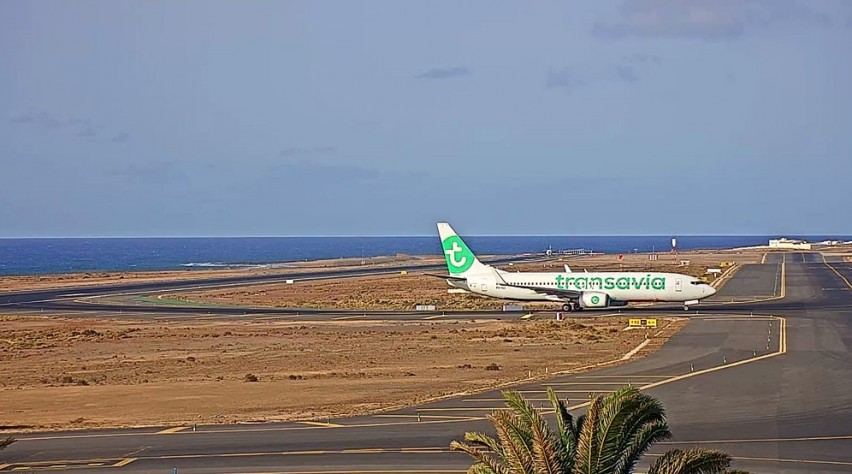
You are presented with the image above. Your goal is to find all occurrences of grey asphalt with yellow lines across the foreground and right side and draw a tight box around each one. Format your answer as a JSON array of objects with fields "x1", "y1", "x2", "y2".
[{"x1": 0, "y1": 253, "x2": 852, "y2": 473}]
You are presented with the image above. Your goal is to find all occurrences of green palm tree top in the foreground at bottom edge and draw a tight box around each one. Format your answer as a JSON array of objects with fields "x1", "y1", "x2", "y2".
[{"x1": 450, "y1": 387, "x2": 744, "y2": 474}]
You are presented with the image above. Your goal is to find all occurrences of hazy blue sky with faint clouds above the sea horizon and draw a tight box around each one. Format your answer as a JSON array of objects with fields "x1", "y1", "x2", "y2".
[{"x1": 0, "y1": 0, "x2": 852, "y2": 237}]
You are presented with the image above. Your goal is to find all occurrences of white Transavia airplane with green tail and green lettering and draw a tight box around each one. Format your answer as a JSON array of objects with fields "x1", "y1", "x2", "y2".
[{"x1": 437, "y1": 222, "x2": 716, "y2": 311}]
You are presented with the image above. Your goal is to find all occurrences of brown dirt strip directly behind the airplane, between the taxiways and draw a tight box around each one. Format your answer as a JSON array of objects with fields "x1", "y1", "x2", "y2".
[{"x1": 163, "y1": 248, "x2": 763, "y2": 311}]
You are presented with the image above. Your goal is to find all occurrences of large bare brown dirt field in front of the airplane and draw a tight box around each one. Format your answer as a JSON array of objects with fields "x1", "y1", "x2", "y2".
[{"x1": 0, "y1": 316, "x2": 685, "y2": 431}]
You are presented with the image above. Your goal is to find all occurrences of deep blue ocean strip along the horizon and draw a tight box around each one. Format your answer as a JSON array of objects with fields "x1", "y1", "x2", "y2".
[{"x1": 0, "y1": 235, "x2": 852, "y2": 275}]
